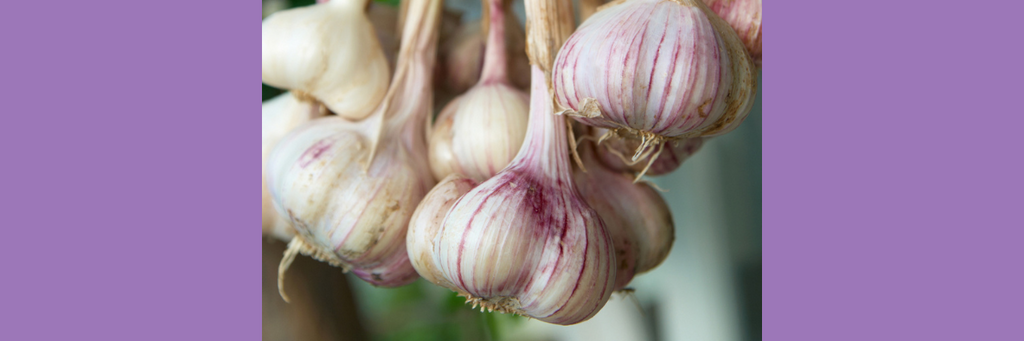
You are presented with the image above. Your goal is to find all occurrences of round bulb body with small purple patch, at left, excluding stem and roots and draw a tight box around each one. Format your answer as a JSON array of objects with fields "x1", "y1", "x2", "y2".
[{"x1": 267, "y1": 117, "x2": 433, "y2": 287}]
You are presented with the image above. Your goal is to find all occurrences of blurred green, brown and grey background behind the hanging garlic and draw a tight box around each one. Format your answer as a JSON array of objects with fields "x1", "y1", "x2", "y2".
[{"x1": 262, "y1": 0, "x2": 763, "y2": 341}]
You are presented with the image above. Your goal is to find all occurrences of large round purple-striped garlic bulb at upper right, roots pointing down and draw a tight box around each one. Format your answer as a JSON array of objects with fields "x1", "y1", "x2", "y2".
[{"x1": 552, "y1": 0, "x2": 757, "y2": 140}]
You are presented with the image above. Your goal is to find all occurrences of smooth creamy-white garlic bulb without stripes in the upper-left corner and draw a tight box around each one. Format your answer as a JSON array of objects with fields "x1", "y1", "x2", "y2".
[{"x1": 262, "y1": 0, "x2": 388, "y2": 120}]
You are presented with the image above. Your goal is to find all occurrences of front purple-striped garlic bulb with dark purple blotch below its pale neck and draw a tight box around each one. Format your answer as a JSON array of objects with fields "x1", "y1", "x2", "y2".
[{"x1": 408, "y1": 66, "x2": 615, "y2": 325}]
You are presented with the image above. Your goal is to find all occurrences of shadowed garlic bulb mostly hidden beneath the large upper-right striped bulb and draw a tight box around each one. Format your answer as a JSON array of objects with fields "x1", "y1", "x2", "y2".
[{"x1": 594, "y1": 128, "x2": 708, "y2": 175}]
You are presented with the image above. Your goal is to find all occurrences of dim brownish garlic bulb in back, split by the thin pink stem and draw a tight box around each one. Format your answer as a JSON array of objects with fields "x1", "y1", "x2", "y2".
[{"x1": 439, "y1": 0, "x2": 529, "y2": 93}]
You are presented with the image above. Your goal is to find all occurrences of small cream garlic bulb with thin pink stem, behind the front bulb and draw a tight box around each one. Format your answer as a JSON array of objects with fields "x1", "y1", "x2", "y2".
[{"x1": 429, "y1": 0, "x2": 529, "y2": 181}]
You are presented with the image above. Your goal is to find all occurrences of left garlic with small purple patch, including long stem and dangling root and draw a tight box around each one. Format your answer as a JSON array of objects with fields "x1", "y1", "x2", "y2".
[{"x1": 267, "y1": 0, "x2": 440, "y2": 297}]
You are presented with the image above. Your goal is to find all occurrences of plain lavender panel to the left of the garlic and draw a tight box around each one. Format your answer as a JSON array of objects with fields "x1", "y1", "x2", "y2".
[{"x1": 0, "y1": 1, "x2": 260, "y2": 340}]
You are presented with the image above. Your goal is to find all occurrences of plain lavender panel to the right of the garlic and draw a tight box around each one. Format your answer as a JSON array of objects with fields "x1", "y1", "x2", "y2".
[{"x1": 763, "y1": 1, "x2": 1024, "y2": 340}]
